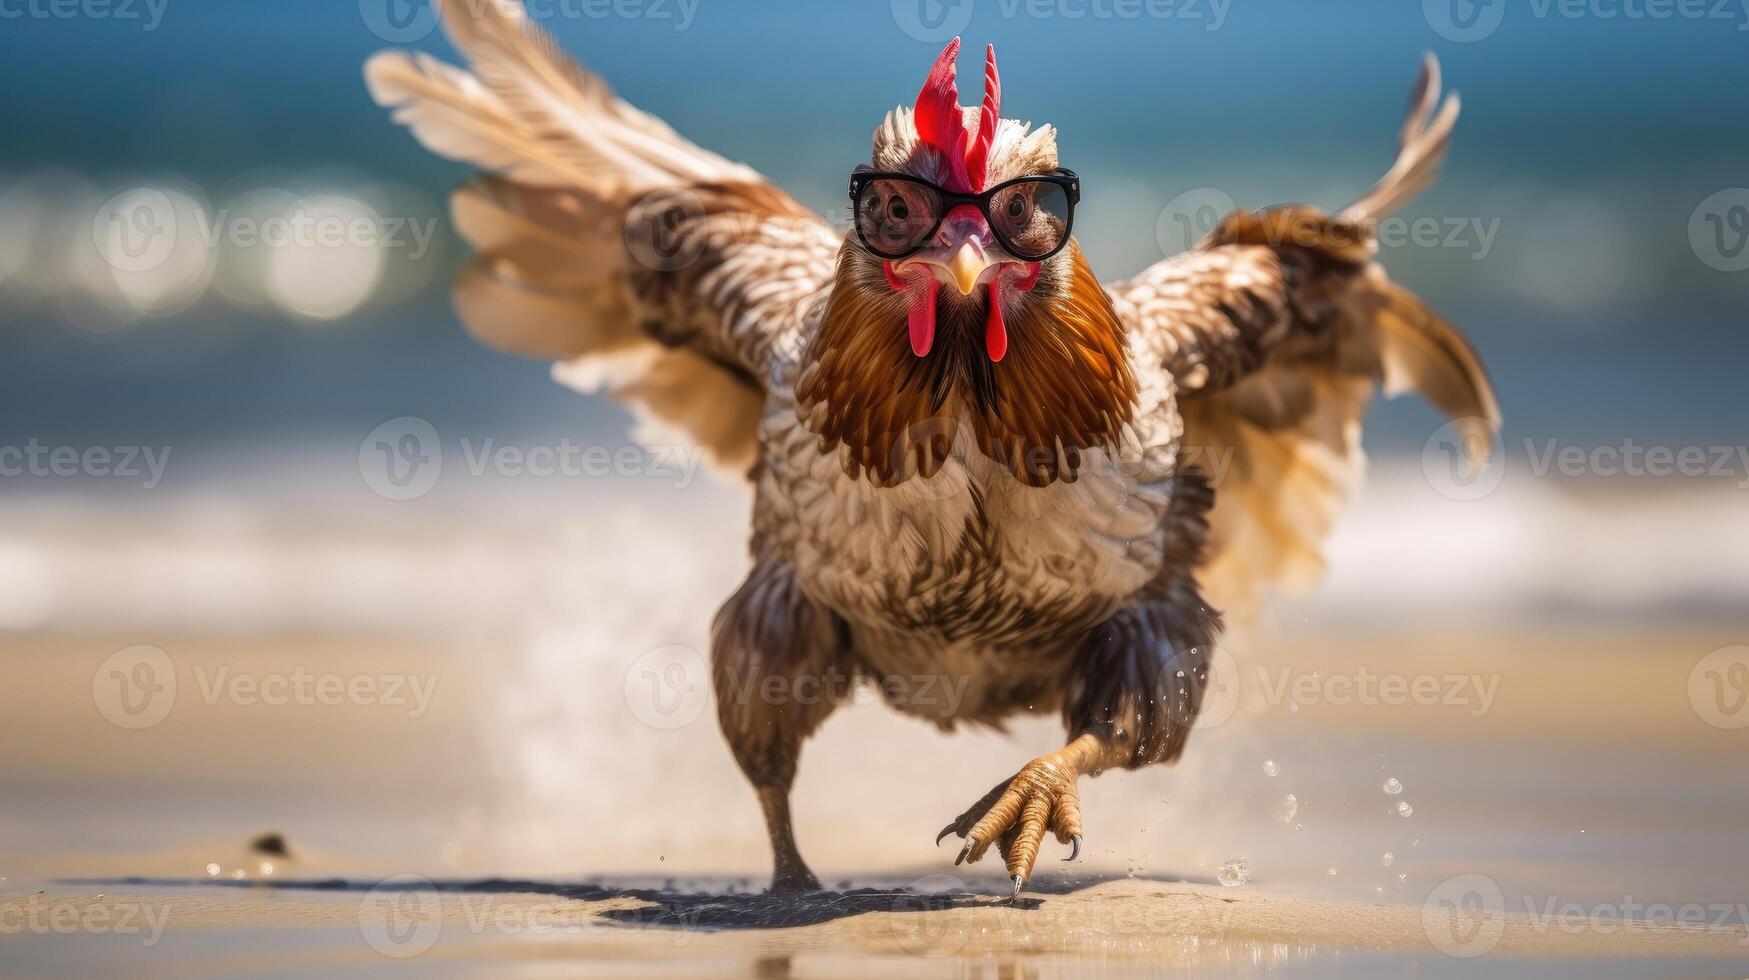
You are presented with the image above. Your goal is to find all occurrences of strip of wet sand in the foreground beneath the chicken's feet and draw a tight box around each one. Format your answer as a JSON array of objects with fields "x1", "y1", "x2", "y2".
[{"x1": 10, "y1": 879, "x2": 1749, "y2": 977}]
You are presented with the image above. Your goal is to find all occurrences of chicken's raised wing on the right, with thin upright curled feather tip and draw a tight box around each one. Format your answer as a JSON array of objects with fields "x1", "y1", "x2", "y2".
[{"x1": 1111, "y1": 56, "x2": 1499, "y2": 614}]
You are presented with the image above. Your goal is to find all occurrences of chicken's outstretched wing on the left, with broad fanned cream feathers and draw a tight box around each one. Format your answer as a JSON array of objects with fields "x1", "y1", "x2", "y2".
[{"x1": 364, "y1": 0, "x2": 841, "y2": 467}]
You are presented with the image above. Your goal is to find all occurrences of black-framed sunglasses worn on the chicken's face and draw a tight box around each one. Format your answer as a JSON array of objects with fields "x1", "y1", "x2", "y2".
[{"x1": 850, "y1": 170, "x2": 1081, "y2": 263}]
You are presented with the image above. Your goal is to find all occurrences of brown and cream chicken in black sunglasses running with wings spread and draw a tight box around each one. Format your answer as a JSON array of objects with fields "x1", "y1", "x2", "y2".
[{"x1": 366, "y1": 0, "x2": 1499, "y2": 894}]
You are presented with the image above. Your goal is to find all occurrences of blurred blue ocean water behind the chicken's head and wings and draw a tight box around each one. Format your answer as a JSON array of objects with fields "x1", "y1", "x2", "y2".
[{"x1": 0, "y1": 0, "x2": 1749, "y2": 459}]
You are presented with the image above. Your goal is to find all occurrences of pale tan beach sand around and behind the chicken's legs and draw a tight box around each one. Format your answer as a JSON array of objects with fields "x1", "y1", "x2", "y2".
[{"x1": 0, "y1": 472, "x2": 1749, "y2": 977}]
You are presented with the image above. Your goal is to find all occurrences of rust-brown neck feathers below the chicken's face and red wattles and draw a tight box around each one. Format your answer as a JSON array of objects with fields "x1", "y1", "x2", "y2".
[{"x1": 796, "y1": 245, "x2": 1135, "y2": 487}]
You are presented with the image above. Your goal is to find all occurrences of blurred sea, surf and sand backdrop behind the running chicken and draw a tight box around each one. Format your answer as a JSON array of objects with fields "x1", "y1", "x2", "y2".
[{"x1": 0, "y1": 0, "x2": 1749, "y2": 928}]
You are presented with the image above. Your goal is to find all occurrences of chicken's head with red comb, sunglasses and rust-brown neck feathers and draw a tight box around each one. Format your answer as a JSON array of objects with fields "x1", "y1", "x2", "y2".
[{"x1": 798, "y1": 39, "x2": 1135, "y2": 487}]
